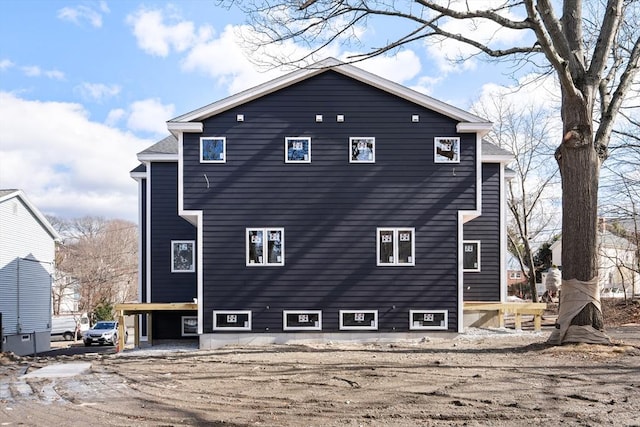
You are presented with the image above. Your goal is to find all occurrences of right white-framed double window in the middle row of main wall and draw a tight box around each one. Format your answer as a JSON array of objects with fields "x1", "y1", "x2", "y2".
[{"x1": 376, "y1": 227, "x2": 416, "y2": 266}]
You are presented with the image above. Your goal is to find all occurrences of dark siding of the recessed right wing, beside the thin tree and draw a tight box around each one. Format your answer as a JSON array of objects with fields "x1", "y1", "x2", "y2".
[{"x1": 463, "y1": 163, "x2": 501, "y2": 301}]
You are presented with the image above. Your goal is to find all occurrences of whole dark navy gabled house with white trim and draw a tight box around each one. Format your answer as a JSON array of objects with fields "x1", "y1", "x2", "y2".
[{"x1": 132, "y1": 59, "x2": 512, "y2": 348}]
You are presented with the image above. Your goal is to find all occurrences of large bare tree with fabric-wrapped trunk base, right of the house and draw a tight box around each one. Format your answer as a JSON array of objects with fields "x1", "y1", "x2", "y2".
[{"x1": 231, "y1": 0, "x2": 640, "y2": 343}]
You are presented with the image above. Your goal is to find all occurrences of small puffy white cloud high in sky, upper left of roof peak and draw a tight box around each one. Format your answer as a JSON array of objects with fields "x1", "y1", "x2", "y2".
[{"x1": 127, "y1": 9, "x2": 213, "y2": 57}]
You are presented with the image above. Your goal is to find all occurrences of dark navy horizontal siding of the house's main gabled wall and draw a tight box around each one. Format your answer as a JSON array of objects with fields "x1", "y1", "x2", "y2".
[{"x1": 180, "y1": 71, "x2": 478, "y2": 333}]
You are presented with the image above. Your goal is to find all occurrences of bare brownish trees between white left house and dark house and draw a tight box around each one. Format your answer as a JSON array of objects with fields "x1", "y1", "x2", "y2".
[{"x1": 50, "y1": 217, "x2": 138, "y2": 318}]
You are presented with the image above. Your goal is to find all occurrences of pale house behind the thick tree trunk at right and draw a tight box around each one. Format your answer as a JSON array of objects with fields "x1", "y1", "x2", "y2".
[{"x1": 551, "y1": 230, "x2": 640, "y2": 298}]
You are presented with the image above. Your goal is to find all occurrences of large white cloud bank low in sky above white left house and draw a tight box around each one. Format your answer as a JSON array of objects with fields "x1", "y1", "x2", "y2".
[{"x1": 0, "y1": 92, "x2": 155, "y2": 220}]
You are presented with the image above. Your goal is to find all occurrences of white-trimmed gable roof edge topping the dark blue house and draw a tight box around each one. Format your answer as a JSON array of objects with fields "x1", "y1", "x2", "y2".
[{"x1": 167, "y1": 58, "x2": 492, "y2": 135}]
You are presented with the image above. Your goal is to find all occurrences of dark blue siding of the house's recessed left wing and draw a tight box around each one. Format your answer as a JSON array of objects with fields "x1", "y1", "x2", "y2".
[{"x1": 148, "y1": 162, "x2": 197, "y2": 302}]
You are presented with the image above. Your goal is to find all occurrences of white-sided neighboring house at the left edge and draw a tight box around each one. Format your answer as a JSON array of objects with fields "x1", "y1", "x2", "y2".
[{"x1": 0, "y1": 190, "x2": 60, "y2": 356}]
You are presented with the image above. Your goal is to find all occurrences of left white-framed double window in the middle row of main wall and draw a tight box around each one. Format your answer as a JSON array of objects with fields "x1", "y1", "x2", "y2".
[{"x1": 247, "y1": 228, "x2": 284, "y2": 266}]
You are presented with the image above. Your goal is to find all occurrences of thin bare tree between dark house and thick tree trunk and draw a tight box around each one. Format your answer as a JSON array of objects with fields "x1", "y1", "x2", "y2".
[{"x1": 473, "y1": 92, "x2": 560, "y2": 301}]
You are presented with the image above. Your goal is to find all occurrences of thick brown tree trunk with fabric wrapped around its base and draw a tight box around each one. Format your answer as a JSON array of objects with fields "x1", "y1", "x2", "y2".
[{"x1": 549, "y1": 90, "x2": 608, "y2": 344}]
